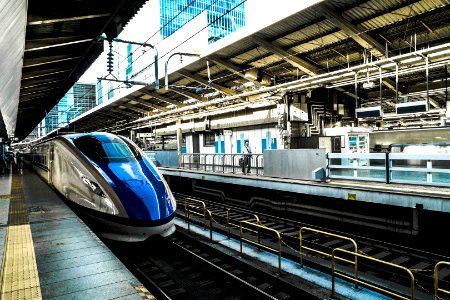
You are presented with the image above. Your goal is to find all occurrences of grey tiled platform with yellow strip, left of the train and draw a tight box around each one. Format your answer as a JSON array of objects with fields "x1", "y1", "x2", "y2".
[{"x1": 0, "y1": 168, "x2": 155, "y2": 300}]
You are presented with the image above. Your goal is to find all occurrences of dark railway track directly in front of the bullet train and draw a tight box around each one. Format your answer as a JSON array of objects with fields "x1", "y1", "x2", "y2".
[{"x1": 106, "y1": 229, "x2": 328, "y2": 300}]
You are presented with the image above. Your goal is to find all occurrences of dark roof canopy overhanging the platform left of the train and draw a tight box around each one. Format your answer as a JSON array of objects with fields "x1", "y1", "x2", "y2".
[{"x1": 0, "y1": 0, "x2": 145, "y2": 139}]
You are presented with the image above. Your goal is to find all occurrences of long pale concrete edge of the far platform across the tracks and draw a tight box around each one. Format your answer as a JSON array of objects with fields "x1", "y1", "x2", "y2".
[{"x1": 159, "y1": 167, "x2": 450, "y2": 212}]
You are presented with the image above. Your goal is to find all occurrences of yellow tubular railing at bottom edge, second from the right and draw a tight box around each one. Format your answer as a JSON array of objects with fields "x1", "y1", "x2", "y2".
[{"x1": 331, "y1": 248, "x2": 415, "y2": 300}]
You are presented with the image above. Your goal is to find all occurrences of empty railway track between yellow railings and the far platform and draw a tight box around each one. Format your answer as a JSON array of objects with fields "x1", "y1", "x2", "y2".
[{"x1": 176, "y1": 194, "x2": 450, "y2": 299}]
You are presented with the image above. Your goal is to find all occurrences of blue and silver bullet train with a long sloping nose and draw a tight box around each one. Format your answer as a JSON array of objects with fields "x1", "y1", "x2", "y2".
[{"x1": 29, "y1": 132, "x2": 176, "y2": 242}]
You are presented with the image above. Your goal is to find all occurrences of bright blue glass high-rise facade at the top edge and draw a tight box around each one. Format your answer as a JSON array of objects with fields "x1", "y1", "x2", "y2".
[{"x1": 159, "y1": 0, "x2": 245, "y2": 43}]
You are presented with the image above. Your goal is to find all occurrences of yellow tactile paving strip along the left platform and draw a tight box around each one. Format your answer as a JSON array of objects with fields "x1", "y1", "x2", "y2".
[{"x1": 0, "y1": 174, "x2": 42, "y2": 300}]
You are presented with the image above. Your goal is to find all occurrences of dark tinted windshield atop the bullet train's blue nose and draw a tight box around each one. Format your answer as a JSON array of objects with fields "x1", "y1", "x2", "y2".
[{"x1": 73, "y1": 135, "x2": 139, "y2": 163}]
